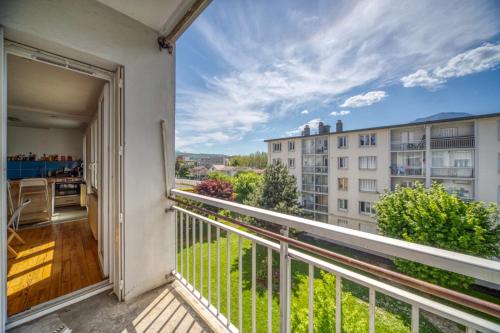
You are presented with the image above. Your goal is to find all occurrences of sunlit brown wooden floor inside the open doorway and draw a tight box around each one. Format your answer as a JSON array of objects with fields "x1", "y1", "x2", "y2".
[{"x1": 7, "y1": 219, "x2": 103, "y2": 316}]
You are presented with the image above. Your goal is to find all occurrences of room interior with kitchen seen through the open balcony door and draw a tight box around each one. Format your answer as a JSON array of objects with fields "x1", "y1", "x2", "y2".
[{"x1": 7, "y1": 54, "x2": 106, "y2": 316}]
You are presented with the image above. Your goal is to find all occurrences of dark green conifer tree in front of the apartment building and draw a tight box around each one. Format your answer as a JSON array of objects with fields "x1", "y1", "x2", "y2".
[{"x1": 260, "y1": 162, "x2": 302, "y2": 215}]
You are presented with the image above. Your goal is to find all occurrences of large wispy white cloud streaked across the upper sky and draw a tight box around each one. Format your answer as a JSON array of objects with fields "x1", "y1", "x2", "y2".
[{"x1": 176, "y1": 0, "x2": 500, "y2": 148}]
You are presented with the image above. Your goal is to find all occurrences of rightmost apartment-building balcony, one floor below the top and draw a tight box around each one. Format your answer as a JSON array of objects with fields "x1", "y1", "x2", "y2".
[{"x1": 431, "y1": 150, "x2": 474, "y2": 178}]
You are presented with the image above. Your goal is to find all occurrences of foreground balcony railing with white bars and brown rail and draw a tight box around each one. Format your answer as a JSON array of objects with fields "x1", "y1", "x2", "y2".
[{"x1": 171, "y1": 190, "x2": 500, "y2": 333}]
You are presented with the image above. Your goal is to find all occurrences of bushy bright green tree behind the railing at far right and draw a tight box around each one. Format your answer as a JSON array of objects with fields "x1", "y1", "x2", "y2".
[{"x1": 375, "y1": 183, "x2": 500, "y2": 288}]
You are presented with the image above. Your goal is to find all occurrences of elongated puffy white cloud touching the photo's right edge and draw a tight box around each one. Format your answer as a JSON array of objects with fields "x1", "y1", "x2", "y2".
[{"x1": 401, "y1": 43, "x2": 500, "y2": 89}]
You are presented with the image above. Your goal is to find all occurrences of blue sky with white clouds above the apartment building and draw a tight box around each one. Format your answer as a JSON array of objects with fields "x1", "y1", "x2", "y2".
[{"x1": 176, "y1": 0, "x2": 500, "y2": 155}]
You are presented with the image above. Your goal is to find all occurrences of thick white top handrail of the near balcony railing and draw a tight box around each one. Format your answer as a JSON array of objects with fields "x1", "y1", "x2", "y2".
[{"x1": 172, "y1": 189, "x2": 500, "y2": 284}]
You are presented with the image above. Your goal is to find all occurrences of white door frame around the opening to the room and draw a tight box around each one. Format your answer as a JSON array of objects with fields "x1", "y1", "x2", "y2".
[{"x1": 0, "y1": 39, "x2": 124, "y2": 331}]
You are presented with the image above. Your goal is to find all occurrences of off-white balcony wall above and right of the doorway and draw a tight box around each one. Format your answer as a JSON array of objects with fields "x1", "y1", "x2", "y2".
[{"x1": 0, "y1": 0, "x2": 175, "y2": 299}]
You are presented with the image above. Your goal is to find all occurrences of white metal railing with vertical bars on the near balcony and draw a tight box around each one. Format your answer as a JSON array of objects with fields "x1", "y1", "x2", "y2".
[{"x1": 172, "y1": 190, "x2": 500, "y2": 333}]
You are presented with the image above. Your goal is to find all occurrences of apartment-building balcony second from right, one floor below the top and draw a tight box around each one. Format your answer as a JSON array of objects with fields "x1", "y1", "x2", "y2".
[{"x1": 390, "y1": 151, "x2": 425, "y2": 177}]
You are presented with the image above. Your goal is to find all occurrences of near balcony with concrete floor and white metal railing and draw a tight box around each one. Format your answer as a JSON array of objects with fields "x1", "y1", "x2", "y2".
[{"x1": 14, "y1": 190, "x2": 500, "y2": 333}]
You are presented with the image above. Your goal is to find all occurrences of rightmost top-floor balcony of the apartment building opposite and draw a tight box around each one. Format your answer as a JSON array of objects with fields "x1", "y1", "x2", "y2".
[{"x1": 430, "y1": 122, "x2": 475, "y2": 149}]
